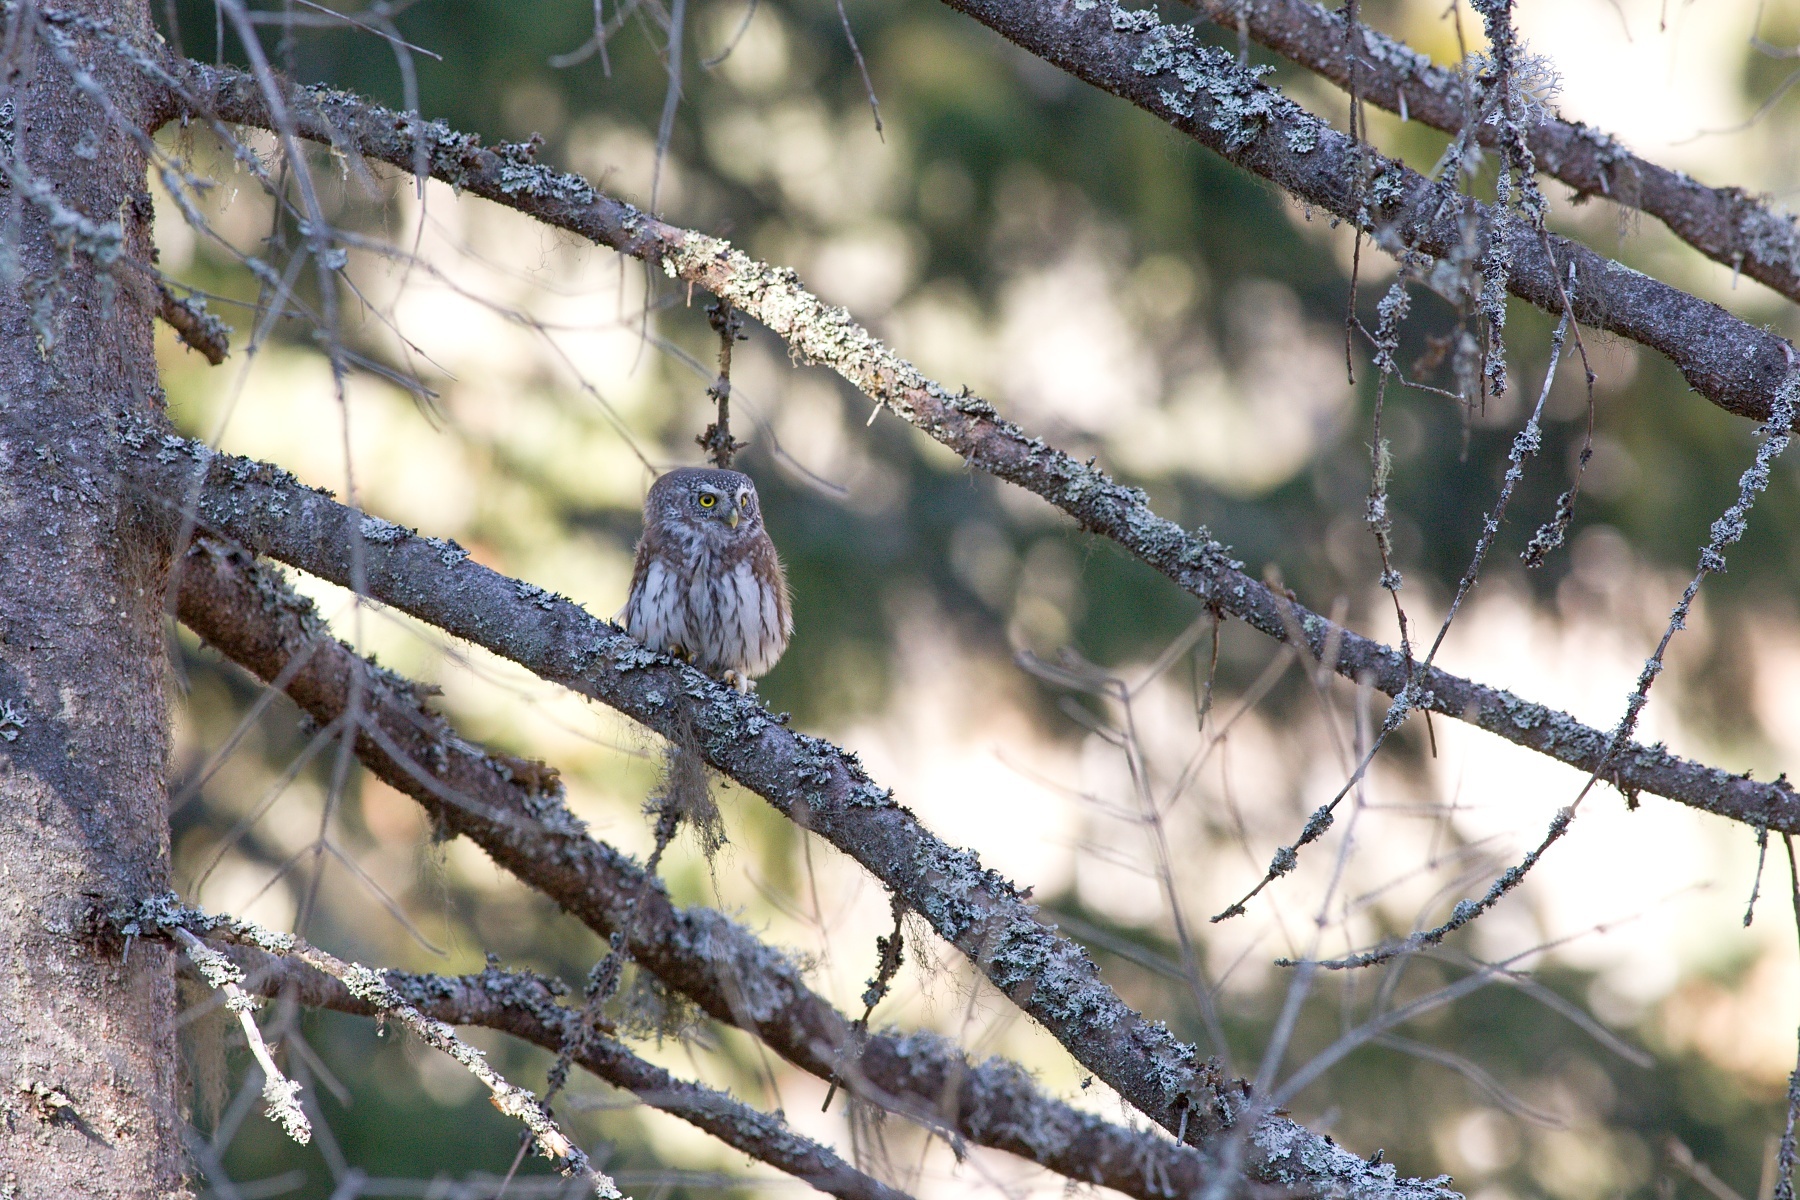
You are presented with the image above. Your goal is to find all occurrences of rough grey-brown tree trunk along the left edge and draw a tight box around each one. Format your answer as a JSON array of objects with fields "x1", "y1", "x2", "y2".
[{"x1": 0, "y1": 0, "x2": 185, "y2": 1198}]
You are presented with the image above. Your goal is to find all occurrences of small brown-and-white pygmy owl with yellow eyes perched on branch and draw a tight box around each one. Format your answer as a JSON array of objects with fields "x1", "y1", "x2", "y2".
[{"x1": 616, "y1": 468, "x2": 794, "y2": 691}]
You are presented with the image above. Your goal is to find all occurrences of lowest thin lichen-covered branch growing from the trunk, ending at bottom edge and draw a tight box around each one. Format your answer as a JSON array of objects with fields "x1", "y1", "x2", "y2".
[{"x1": 144, "y1": 910, "x2": 909, "y2": 1200}]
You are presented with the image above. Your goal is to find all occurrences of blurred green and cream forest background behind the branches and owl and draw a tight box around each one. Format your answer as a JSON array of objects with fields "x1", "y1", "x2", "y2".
[{"x1": 147, "y1": 0, "x2": 1800, "y2": 1200}]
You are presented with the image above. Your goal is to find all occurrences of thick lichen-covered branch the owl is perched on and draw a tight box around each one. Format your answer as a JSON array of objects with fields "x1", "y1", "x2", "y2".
[{"x1": 136, "y1": 438, "x2": 1453, "y2": 1200}]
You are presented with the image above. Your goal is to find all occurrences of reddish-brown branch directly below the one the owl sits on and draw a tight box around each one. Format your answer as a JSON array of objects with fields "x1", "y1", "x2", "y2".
[{"x1": 178, "y1": 542, "x2": 1252, "y2": 1200}]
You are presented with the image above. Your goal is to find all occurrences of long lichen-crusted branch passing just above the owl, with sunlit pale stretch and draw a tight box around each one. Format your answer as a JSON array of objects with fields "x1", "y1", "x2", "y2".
[{"x1": 151, "y1": 72, "x2": 1800, "y2": 833}]
